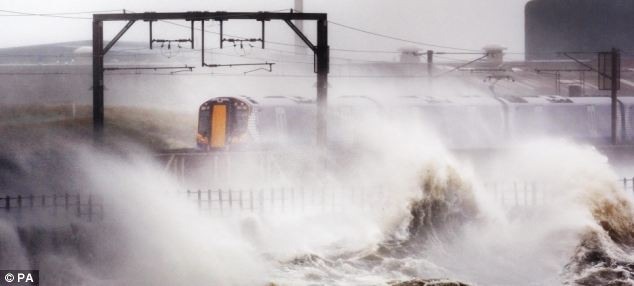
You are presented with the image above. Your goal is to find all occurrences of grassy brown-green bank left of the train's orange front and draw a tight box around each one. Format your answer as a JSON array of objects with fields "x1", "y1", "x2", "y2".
[{"x1": 0, "y1": 105, "x2": 196, "y2": 150}]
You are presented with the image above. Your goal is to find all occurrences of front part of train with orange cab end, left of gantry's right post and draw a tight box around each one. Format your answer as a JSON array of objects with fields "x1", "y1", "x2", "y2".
[{"x1": 196, "y1": 96, "x2": 317, "y2": 150}]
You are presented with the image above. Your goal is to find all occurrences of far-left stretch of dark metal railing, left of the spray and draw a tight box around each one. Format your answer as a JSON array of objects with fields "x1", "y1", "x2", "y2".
[{"x1": 0, "y1": 193, "x2": 104, "y2": 221}]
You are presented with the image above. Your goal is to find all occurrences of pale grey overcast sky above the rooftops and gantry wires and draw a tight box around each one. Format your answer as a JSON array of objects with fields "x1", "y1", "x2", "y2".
[{"x1": 0, "y1": 0, "x2": 527, "y2": 55}]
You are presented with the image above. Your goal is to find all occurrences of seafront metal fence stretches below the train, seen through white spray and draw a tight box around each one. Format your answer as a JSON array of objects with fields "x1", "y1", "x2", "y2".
[{"x1": 180, "y1": 178, "x2": 634, "y2": 214}]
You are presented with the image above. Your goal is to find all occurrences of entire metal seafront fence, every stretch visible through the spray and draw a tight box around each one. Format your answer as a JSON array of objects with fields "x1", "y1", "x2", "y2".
[{"x1": 0, "y1": 178, "x2": 634, "y2": 218}]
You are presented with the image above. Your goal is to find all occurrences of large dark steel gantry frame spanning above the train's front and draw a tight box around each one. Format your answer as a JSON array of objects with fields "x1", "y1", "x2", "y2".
[{"x1": 92, "y1": 11, "x2": 330, "y2": 146}]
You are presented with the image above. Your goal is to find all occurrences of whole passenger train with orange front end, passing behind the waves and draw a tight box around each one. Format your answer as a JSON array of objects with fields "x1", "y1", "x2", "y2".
[{"x1": 196, "y1": 95, "x2": 634, "y2": 151}]
